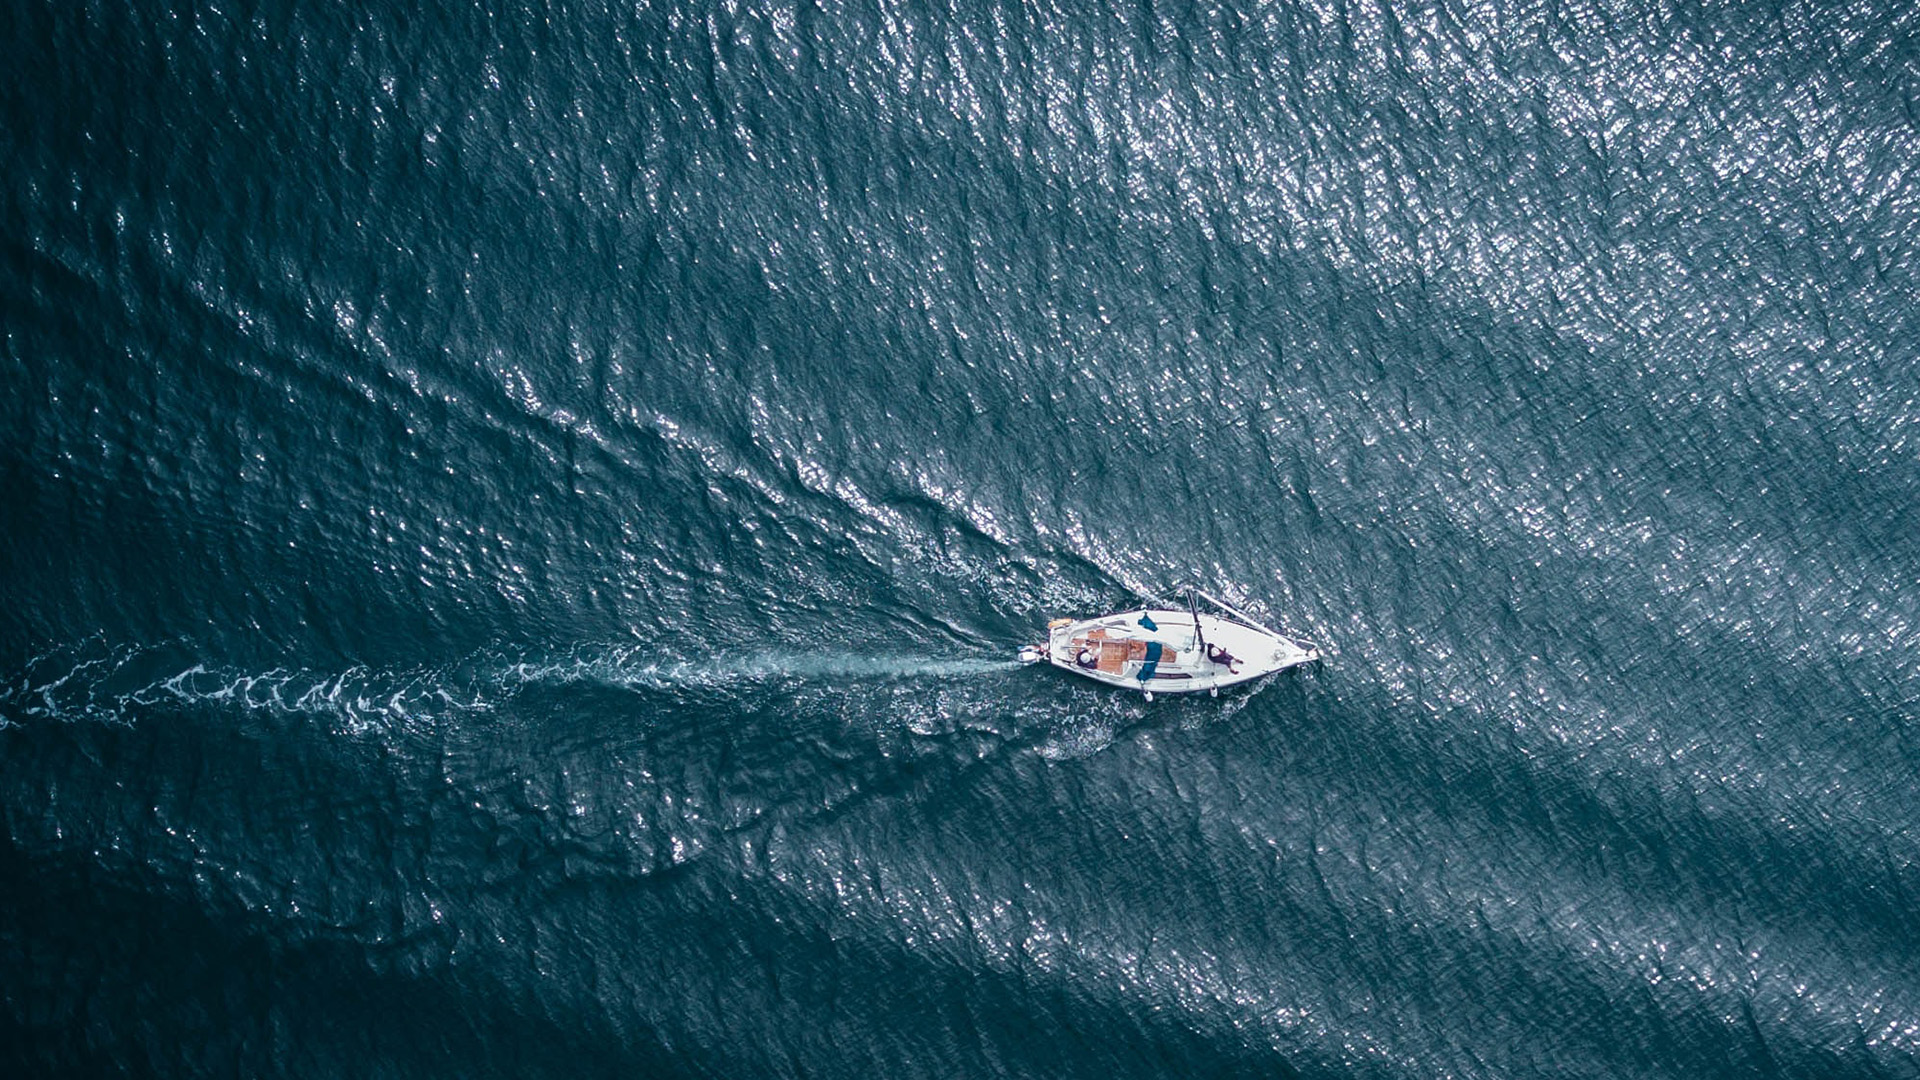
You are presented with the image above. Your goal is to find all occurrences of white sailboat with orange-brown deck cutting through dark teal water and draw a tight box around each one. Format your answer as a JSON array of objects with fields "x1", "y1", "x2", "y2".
[{"x1": 1020, "y1": 588, "x2": 1321, "y2": 701}]
